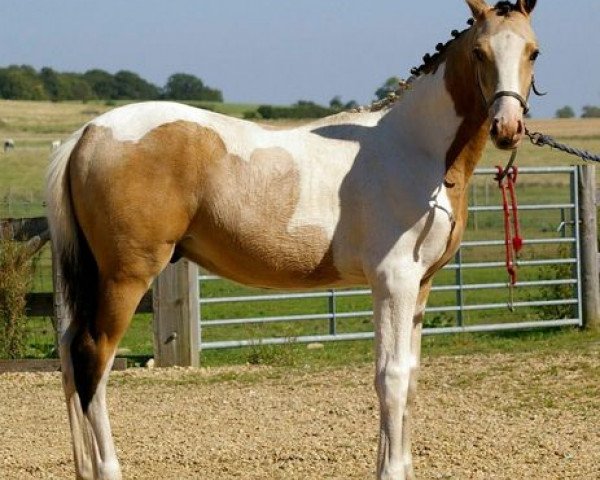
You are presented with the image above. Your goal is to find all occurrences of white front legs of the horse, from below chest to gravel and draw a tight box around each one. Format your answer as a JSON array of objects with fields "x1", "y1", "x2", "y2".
[{"x1": 372, "y1": 268, "x2": 421, "y2": 480}]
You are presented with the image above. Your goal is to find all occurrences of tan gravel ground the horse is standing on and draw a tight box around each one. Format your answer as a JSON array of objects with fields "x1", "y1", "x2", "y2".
[{"x1": 0, "y1": 351, "x2": 600, "y2": 480}]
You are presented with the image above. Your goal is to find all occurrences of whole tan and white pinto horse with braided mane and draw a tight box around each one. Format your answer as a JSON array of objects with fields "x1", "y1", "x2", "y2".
[{"x1": 47, "y1": 0, "x2": 538, "y2": 480}]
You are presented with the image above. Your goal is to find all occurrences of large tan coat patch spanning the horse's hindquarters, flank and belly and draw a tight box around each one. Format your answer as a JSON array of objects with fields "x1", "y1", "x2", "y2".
[{"x1": 71, "y1": 121, "x2": 339, "y2": 288}]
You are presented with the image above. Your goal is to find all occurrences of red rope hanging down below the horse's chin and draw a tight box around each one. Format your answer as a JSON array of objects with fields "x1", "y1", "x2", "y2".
[{"x1": 496, "y1": 153, "x2": 523, "y2": 312}]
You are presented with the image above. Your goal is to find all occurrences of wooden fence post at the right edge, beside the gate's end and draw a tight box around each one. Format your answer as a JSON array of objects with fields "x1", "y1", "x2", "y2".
[{"x1": 578, "y1": 165, "x2": 600, "y2": 330}]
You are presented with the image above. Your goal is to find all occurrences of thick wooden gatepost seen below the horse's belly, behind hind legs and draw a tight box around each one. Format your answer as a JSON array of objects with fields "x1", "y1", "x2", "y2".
[{"x1": 152, "y1": 259, "x2": 200, "y2": 367}]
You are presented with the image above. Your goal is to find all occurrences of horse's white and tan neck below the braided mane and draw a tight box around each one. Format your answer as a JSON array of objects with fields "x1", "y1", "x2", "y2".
[{"x1": 384, "y1": 27, "x2": 489, "y2": 190}]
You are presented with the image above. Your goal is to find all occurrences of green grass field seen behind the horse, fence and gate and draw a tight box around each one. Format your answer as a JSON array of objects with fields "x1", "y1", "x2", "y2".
[{"x1": 0, "y1": 101, "x2": 600, "y2": 363}]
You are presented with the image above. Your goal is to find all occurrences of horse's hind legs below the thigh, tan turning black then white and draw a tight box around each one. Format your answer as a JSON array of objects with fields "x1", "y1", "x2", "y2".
[{"x1": 61, "y1": 276, "x2": 156, "y2": 480}]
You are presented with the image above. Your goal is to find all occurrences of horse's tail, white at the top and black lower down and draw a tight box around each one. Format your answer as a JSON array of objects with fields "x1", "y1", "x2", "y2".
[{"x1": 46, "y1": 128, "x2": 99, "y2": 356}]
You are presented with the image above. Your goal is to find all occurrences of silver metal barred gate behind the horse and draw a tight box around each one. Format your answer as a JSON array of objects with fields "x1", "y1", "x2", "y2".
[{"x1": 199, "y1": 167, "x2": 582, "y2": 349}]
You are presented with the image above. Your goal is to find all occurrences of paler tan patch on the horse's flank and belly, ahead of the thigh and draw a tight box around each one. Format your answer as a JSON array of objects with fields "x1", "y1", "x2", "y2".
[{"x1": 180, "y1": 126, "x2": 340, "y2": 287}]
